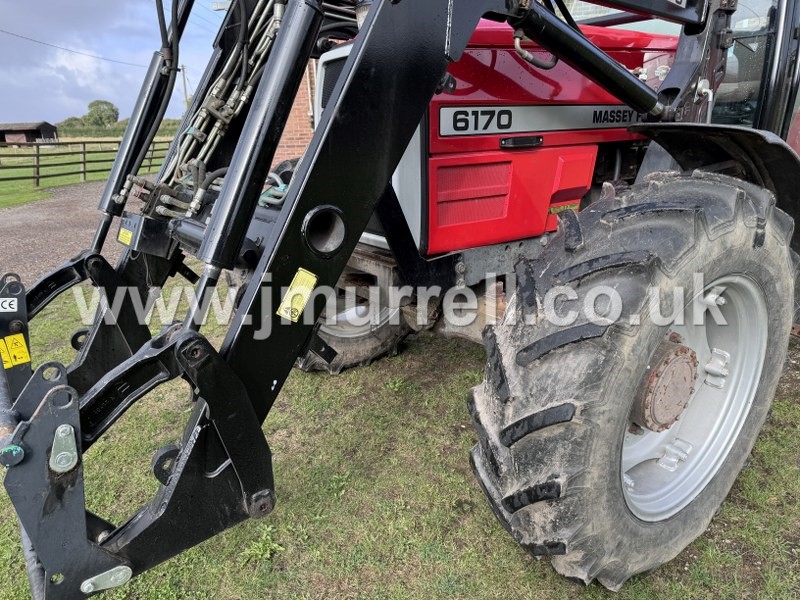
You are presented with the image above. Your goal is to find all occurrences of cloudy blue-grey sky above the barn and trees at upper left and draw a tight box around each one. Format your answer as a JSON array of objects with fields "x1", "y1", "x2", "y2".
[{"x1": 0, "y1": 0, "x2": 224, "y2": 123}]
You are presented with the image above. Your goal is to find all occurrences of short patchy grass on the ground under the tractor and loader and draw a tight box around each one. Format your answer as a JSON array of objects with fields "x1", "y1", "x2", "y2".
[{"x1": 0, "y1": 282, "x2": 800, "y2": 600}]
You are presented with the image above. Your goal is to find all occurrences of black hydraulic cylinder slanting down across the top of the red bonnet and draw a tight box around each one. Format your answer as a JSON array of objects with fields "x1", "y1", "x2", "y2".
[{"x1": 509, "y1": 2, "x2": 664, "y2": 117}]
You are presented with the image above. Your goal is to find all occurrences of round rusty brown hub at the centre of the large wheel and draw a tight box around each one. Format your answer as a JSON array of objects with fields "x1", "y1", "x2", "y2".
[{"x1": 632, "y1": 341, "x2": 698, "y2": 432}]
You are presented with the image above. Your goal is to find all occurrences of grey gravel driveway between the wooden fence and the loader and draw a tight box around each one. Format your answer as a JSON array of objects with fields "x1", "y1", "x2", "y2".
[{"x1": 0, "y1": 181, "x2": 121, "y2": 287}]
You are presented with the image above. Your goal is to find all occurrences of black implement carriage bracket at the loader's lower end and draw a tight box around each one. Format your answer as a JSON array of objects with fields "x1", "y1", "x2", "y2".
[{"x1": 5, "y1": 327, "x2": 275, "y2": 598}]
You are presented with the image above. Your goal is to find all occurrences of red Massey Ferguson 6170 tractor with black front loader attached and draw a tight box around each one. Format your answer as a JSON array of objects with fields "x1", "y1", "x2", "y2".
[{"x1": 0, "y1": 0, "x2": 800, "y2": 598}]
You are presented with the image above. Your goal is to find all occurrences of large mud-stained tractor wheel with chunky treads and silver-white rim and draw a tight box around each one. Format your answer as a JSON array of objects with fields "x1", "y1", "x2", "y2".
[{"x1": 469, "y1": 173, "x2": 795, "y2": 590}]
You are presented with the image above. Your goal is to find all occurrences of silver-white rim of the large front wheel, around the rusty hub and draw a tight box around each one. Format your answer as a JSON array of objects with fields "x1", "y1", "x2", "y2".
[{"x1": 620, "y1": 275, "x2": 769, "y2": 522}]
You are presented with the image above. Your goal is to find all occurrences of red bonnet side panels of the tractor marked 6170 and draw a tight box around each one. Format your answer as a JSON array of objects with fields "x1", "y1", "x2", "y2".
[{"x1": 427, "y1": 21, "x2": 677, "y2": 254}]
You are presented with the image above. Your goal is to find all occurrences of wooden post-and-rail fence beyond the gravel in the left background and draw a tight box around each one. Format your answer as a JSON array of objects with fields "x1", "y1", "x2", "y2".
[{"x1": 0, "y1": 140, "x2": 170, "y2": 187}]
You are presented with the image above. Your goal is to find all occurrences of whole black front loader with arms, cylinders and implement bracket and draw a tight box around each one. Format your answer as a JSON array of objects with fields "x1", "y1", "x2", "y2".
[{"x1": 0, "y1": 0, "x2": 788, "y2": 598}]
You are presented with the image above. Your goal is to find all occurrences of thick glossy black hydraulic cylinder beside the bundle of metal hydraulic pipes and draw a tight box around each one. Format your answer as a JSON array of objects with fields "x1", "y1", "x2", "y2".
[{"x1": 197, "y1": 0, "x2": 323, "y2": 269}]
